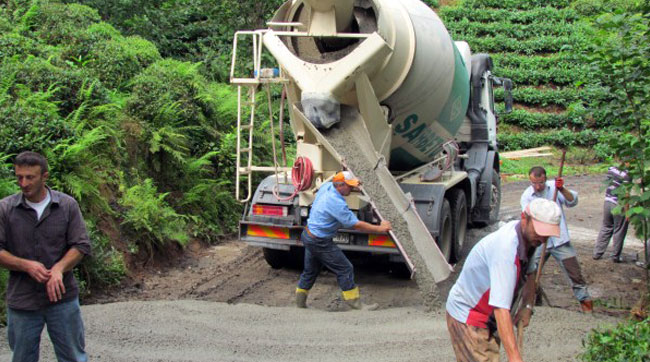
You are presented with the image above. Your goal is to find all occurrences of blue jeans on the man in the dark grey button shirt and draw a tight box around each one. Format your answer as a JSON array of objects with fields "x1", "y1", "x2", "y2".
[{"x1": 7, "y1": 299, "x2": 88, "y2": 362}]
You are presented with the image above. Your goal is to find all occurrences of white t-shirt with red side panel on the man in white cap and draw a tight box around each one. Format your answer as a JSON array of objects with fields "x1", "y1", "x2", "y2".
[{"x1": 446, "y1": 221, "x2": 526, "y2": 328}]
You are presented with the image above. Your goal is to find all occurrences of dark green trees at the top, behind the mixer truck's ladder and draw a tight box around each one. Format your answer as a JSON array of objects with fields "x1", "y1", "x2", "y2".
[{"x1": 65, "y1": 0, "x2": 284, "y2": 82}]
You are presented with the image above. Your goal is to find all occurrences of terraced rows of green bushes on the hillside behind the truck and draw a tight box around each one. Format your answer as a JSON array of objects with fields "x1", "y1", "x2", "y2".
[{"x1": 440, "y1": 0, "x2": 632, "y2": 153}]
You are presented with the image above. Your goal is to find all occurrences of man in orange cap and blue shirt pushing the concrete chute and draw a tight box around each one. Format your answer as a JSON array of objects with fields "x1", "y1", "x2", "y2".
[{"x1": 296, "y1": 171, "x2": 391, "y2": 309}]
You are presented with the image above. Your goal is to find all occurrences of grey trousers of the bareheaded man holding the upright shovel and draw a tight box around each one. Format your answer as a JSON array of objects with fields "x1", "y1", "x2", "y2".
[{"x1": 528, "y1": 242, "x2": 591, "y2": 302}]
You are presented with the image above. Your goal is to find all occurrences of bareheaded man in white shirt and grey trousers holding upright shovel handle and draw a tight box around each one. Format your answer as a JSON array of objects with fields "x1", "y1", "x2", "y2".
[{"x1": 520, "y1": 166, "x2": 593, "y2": 313}]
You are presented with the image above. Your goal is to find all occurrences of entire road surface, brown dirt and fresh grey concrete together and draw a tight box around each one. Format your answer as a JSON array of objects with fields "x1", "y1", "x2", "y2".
[{"x1": 0, "y1": 176, "x2": 643, "y2": 361}]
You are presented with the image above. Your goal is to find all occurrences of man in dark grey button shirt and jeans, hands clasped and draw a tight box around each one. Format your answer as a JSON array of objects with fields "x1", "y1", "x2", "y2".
[{"x1": 0, "y1": 152, "x2": 90, "y2": 362}]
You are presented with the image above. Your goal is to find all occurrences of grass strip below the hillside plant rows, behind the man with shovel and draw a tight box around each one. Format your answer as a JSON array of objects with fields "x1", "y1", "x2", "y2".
[{"x1": 501, "y1": 147, "x2": 609, "y2": 181}]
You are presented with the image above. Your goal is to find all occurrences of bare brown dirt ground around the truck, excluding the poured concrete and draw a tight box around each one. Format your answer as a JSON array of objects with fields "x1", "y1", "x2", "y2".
[{"x1": 86, "y1": 175, "x2": 643, "y2": 315}]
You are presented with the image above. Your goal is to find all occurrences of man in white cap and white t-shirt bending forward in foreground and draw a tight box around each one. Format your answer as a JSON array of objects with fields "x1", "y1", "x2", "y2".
[{"x1": 446, "y1": 199, "x2": 562, "y2": 362}]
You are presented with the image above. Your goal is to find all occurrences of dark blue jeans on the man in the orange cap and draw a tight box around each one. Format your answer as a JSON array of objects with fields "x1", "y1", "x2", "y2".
[{"x1": 298, "y1": 231, "x2": 356, "y2": 291}]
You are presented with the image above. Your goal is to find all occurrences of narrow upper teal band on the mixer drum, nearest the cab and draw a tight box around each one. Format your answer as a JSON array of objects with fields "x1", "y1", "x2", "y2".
[{"x1": 438, "y1": 43, "x2": 469, "y2": 136}]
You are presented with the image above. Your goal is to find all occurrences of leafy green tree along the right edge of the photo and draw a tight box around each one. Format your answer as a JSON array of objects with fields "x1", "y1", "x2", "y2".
[{"x1": 591, "y1": 1, "x2": 650, "y2": 298}]
